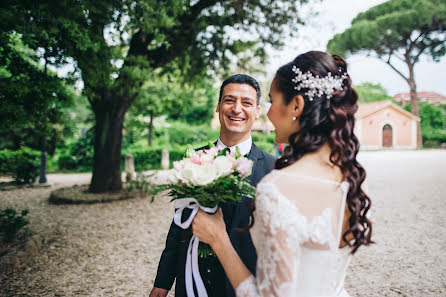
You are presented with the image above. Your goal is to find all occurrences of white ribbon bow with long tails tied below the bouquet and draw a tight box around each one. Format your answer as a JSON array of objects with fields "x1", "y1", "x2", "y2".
[{"x1": 173, "y1": 198, "x2": 218, "y2": 297}]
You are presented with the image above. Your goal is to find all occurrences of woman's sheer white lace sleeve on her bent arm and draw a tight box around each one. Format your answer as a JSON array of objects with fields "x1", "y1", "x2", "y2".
[{"x1": 236, "y1": 182, "x2": 305, "y2": 297}]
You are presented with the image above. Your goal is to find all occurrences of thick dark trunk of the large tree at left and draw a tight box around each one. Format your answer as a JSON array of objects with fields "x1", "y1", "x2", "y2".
[{"x1": 89, "y1": 100, "x2": 127, "y2": 193}]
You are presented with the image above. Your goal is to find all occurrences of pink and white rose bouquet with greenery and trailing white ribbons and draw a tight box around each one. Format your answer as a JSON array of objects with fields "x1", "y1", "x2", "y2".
[{"x1": 154, "y1": 146, "x2": 255, "y2": 297}]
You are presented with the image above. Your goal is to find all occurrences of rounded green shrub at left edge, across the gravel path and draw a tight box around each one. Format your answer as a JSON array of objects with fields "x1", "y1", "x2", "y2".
[{"x1": 0, "y1": 147, "x2": 40, "y2": 184}]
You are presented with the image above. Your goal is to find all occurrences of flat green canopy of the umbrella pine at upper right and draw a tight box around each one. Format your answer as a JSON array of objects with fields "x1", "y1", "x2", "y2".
[{"x1": 327, "y1": 0, "x2": 446, "y2": 62}]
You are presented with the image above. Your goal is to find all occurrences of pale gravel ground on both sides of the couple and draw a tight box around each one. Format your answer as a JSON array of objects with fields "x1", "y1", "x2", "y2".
[{"x1": 0, "y1": 150, "x2": 446, "y2": 297}]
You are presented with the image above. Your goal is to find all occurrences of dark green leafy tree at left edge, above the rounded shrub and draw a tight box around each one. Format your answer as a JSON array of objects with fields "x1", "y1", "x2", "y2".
[{"x1": 0, "y1": 33, "x2": 74, "y2": 149}]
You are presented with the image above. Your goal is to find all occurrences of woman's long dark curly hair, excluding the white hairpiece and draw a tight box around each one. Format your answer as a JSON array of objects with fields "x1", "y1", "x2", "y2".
[{"x1": 262, "y1": 51, "x2": 372, "y2": 253}]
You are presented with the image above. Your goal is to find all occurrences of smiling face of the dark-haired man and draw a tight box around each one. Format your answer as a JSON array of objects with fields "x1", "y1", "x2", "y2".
[{"x1": 217, "y1": 83, "x2": 260, "y2": 137}]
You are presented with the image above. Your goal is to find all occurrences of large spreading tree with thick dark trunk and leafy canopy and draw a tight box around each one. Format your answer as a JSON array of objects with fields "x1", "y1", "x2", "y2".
[{"x1": 6, "y1": 0, "x2": 307, "y2": 192}]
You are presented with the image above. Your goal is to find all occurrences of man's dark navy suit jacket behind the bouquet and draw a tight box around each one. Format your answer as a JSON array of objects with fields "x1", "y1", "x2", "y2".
[{"x1": 154, "y1": 143, "x2": 276, "y2": 297}]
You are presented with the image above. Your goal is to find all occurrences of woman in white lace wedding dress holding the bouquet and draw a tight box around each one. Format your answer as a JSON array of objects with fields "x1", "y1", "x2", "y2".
[{"x1": 193, "y1": 51, "x2": 372, "y2": 297}]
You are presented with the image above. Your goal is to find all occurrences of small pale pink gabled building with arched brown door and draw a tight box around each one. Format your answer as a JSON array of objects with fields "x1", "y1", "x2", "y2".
[{"x1": 355, "y1": 101, "x2": 420, "y2": 149}]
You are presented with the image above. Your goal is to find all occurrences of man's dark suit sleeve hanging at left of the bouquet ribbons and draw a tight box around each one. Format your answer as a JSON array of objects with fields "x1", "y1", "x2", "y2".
[{"x1": 154, "y1": 221, "x2": 182, "y2": 290}]
